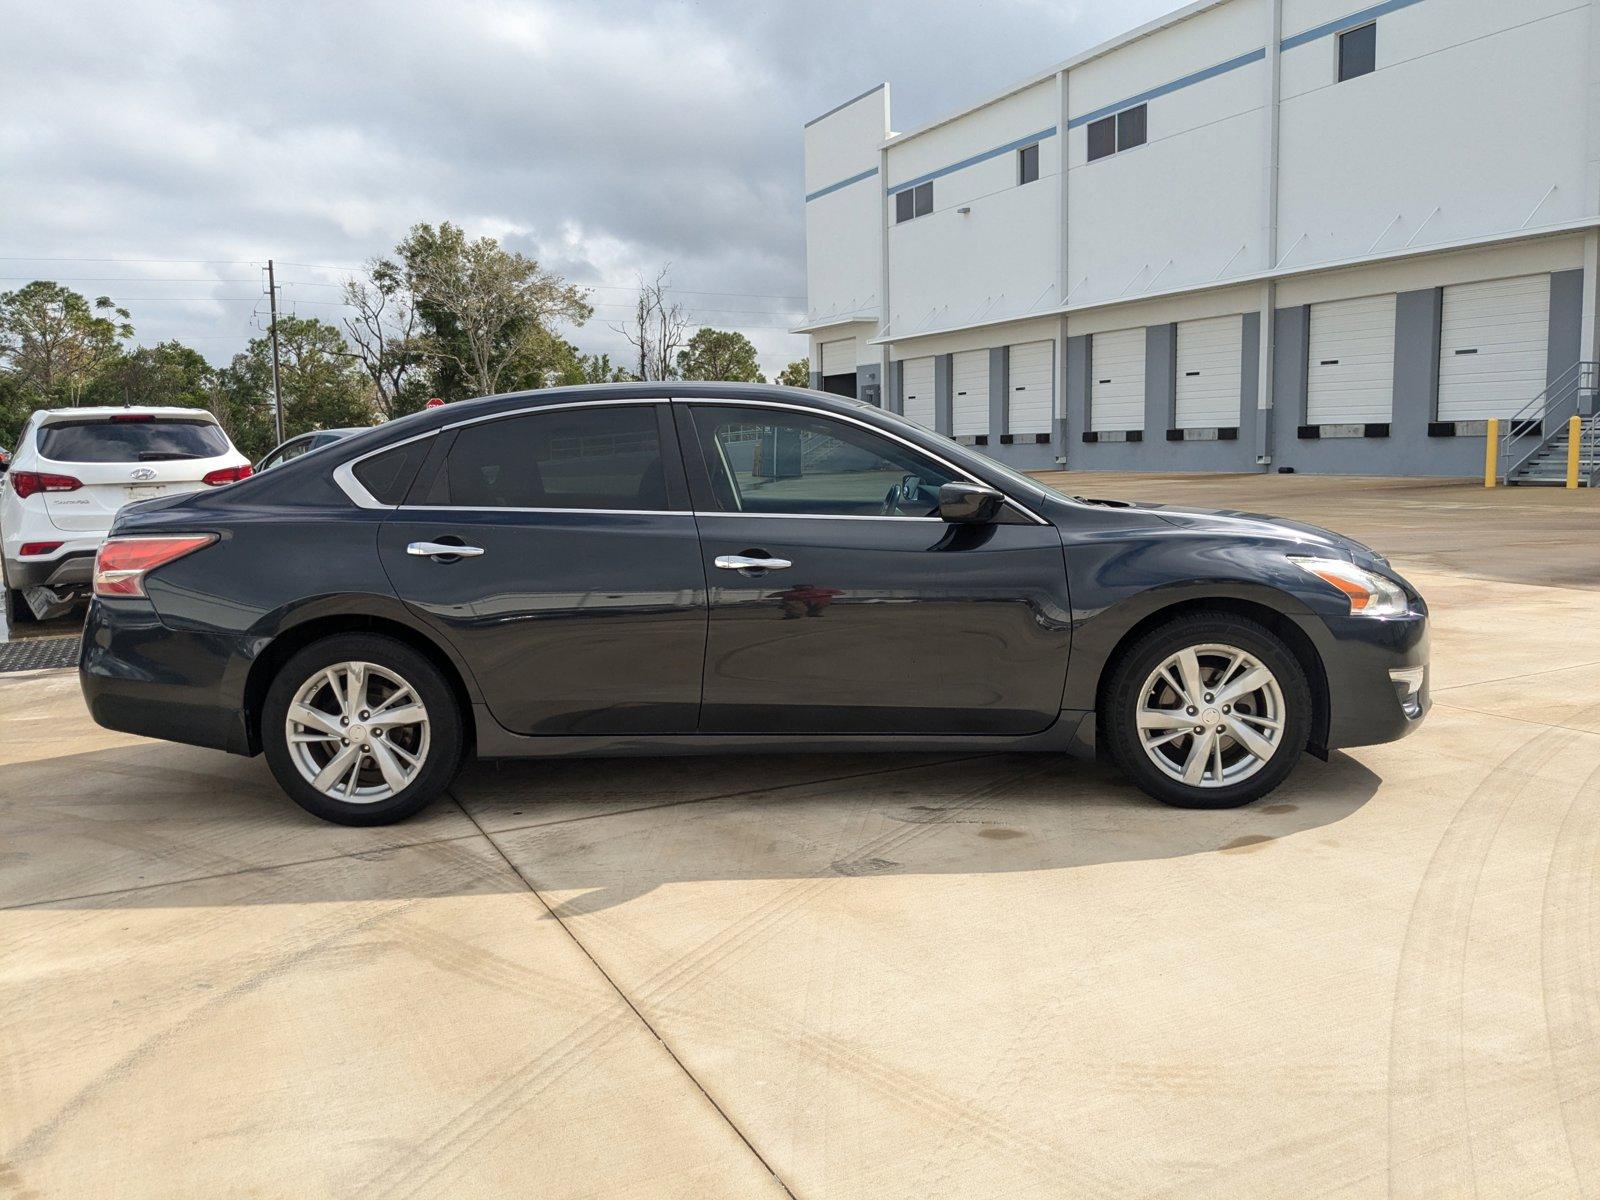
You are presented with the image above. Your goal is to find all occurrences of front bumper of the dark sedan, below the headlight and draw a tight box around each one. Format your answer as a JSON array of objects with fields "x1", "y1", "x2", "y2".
[{"x1": 1299, "y1": 611, "x2": 1434, "y2": 750}]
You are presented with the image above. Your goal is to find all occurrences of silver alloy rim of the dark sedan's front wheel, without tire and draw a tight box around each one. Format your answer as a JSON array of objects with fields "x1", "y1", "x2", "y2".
[{"x1": 1138, "y1": 643, "x2": 1286, "y2": 787}]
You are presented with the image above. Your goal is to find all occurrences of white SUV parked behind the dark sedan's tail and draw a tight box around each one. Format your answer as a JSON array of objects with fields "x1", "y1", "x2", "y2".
[{"x1": 0, "y1": 408, "x2": 250, "y2": 621}]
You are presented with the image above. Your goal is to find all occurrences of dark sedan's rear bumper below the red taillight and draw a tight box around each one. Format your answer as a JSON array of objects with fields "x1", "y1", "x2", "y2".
[{"x1": 78, "y1": 598, "x2": 254, "y2": 754}]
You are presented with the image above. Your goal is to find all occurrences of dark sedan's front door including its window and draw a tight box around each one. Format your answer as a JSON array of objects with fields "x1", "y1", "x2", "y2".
[{"x1": 675, "y1": 400, "x2": 1072, "y2": 734}]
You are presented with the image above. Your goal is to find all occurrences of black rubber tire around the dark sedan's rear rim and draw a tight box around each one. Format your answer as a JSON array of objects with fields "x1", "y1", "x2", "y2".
[{"x1": 261, "y1": 634, "x2": 466, "y2": 826}]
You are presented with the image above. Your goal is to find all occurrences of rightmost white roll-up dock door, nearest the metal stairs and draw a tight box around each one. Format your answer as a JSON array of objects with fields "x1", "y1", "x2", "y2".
[{"x1": 1438, "y1": 275, "x2": 1550, "y2": 421}]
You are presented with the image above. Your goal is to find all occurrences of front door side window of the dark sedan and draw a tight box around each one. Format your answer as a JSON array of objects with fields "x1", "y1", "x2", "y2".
[{"x1": 694, "y1": 405, "x2": 962, "y2": 517}]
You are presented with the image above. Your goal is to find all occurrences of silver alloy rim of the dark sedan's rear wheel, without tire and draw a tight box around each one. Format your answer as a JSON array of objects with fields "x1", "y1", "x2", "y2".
[{"x1": 283, "y1": 662, "x2": 429, "y2": 805}]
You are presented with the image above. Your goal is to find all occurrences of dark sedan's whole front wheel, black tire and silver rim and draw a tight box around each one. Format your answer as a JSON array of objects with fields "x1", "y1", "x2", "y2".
[{"x1": 1101, "y1": 613, "x2": 1312, "y2": 808}]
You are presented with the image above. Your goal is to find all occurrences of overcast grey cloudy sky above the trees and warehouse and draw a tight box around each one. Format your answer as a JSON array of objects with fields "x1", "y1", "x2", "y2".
[{"x1": 0, "y1": 0, "x2": 1178, "y2": 374}]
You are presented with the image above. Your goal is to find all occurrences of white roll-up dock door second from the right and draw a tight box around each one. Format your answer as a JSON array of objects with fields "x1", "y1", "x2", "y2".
[{"x1": 1306, "y1": 296, "x2": 1395, "y2": 426}]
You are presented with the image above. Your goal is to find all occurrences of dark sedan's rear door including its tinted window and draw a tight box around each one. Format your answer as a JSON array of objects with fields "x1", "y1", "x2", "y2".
[{"x1": 379, "y1": 400, "x2": 706, "y2": 734}]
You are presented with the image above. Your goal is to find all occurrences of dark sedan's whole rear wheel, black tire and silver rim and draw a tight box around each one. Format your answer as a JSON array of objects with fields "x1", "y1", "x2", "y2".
[{"x1": 261, "y1": 634, "x2": 464, "y2": 826}]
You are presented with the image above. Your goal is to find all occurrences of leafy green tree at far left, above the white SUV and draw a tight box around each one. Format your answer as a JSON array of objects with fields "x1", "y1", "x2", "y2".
[{"x1": 0, "y1": 280, "x2": 133, "y2": 406}]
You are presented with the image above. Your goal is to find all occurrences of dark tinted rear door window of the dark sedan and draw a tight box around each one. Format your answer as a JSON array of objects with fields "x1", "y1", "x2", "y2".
[{"x1": 429, "y1": 405, "x2": 667, "y2": 510}]
